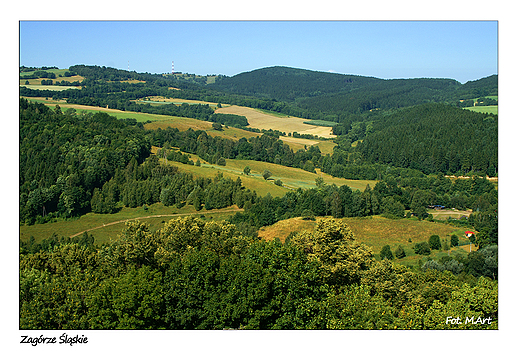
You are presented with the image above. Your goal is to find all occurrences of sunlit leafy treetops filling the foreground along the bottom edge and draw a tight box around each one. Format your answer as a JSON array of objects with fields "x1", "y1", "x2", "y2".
[{"x1": 19, "y1": 217, "x2": 498, "y2": 330}]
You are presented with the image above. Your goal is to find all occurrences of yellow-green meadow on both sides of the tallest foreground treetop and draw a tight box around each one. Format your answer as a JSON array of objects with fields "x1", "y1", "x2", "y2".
[{"x1": 258, "y1": 216, "x2": 475, "y2": 265}]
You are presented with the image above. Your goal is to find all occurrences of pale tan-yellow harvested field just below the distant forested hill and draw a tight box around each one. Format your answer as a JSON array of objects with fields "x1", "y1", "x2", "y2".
[{"x1": 215, "y1": 106, "x2": 335, "y2": 138}]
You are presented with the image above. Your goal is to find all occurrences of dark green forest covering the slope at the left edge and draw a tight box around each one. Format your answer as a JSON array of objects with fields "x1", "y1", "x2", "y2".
[{"x1": 20, "y1": 99, "x2": 256, "y2": 224}]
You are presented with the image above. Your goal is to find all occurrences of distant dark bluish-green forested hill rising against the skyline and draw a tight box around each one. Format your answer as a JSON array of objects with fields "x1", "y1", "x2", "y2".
[{"x1": 212, "y1": 67, "x2": 498, "y2": 122}]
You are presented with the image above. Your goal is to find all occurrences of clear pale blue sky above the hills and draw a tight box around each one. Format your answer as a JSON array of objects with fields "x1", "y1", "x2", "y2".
[{"x1": 19, "y1": 20, "x2": 498, "y2": 83}]
